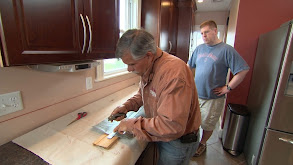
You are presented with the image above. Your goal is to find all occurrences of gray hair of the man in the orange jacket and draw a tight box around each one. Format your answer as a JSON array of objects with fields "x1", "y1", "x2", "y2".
[{"x1": 116, "y1": 29, "x2": 157, "y2": 60}]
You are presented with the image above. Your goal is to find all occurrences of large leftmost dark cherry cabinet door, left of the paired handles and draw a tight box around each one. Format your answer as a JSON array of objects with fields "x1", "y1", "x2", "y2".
[{"x1": 0, "y1": 0, "x2": 83, "y2": 66}]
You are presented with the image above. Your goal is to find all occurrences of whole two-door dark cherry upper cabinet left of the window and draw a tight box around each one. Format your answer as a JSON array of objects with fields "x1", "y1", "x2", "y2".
[{"x1": 0, "y1": 0, "x2": 119, "y2": 66}]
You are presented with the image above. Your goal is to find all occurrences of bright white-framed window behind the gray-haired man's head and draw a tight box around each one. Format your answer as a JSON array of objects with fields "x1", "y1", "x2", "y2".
[{"x1": 96, "y1": 0, "x2": 141, "y2": 81}]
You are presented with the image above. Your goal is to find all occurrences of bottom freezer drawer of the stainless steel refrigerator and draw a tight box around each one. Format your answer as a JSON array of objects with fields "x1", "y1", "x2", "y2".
[{"x1": 259, "y1": 129, "x2": 293, "y2": 165}]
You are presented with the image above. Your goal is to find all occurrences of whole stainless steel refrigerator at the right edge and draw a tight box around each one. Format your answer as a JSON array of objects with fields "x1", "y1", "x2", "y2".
[{"x1": 244, "y1": 20, "x2": 293, "y2": 165}]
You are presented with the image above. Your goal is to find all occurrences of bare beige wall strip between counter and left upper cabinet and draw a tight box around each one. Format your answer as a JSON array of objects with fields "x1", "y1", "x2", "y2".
[{"x1": 0, "y1": 66, "x2": 139, "y2": 145}]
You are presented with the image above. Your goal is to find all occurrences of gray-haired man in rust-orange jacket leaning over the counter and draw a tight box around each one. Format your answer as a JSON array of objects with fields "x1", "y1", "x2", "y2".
[{"x1": 112, "y1": 29, "x2": 201, "y2": 165}]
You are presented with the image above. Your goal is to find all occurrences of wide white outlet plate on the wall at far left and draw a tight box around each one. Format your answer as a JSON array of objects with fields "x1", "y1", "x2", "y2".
[{"x1": 0, "y1": 91, "x2": 23, "y2": 116}]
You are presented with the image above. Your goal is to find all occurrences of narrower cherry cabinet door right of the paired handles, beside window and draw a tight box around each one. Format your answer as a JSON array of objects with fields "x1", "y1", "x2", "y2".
[{"x1": 84, "y1": 0, "x2": 119, "y2": 59}]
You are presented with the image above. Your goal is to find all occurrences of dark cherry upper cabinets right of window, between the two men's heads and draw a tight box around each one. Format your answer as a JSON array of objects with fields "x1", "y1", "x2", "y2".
[{"x1": 141, "y1": 0, "x2": 196, "y2": 62}]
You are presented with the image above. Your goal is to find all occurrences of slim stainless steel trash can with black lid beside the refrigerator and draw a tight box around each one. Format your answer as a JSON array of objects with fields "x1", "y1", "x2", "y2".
[{"x1": 222, "y1": 104, "x2": 249, "y2": 156}]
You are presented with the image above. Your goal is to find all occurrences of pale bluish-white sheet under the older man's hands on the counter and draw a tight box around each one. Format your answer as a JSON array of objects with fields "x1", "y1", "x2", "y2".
[{"x1": 93, "y1": 106, "x2": 145, "y2": 138}]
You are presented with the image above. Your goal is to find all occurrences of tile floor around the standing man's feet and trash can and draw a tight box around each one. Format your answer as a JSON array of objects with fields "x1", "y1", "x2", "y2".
[{"x1": 189, "y1": 124, "x2": 247, "y2": 165}]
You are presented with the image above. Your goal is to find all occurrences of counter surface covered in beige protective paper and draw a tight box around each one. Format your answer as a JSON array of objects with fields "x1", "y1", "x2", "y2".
[{"x1": 13, "y1": 85, "x2": 147, "y2": 165}]
